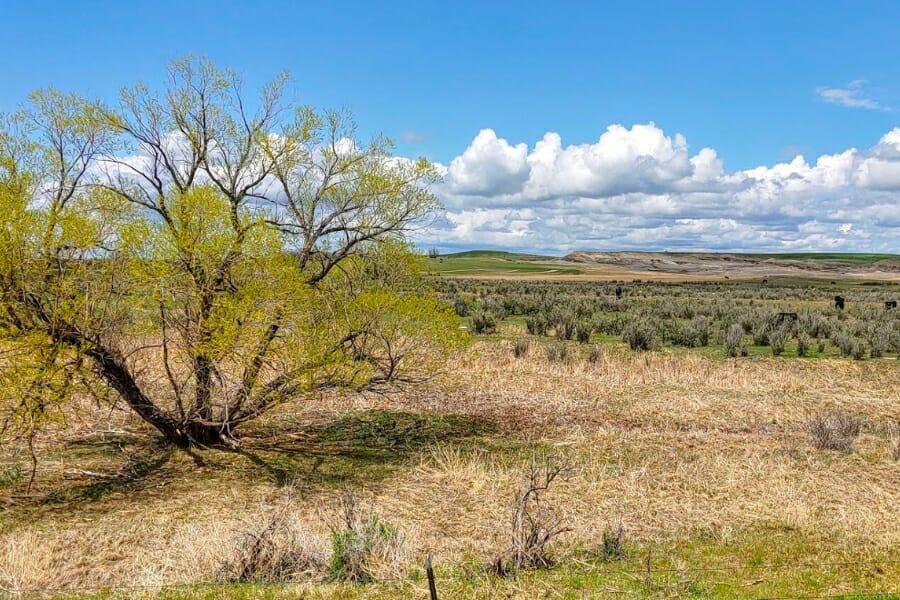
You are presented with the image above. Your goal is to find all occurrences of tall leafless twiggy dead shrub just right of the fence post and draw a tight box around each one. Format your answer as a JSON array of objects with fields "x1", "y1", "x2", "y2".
[{"x1": 490, "y1": 457, "x2": 571, "y2": 577}]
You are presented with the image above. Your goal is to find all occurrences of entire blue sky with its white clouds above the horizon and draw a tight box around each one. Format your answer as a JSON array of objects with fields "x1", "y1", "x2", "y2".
[{"x1": 0, "y1": 0, "x2": 900, "y2": 253}]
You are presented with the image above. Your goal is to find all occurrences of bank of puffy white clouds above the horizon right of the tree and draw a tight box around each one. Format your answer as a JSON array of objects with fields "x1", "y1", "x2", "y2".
[{"x1": 420, "y1": 123, "x2": 900, "y2": 252}]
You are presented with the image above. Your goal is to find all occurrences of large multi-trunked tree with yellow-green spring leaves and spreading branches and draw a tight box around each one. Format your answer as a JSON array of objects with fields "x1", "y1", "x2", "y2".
[{"x1": 0, "y1": 59, "x2": 460, "y2": 448}]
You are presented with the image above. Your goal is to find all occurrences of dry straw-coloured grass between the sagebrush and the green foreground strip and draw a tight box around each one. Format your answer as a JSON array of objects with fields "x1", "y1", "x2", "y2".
[{"x1": 0, "y1": 343, "x2": 900, "y2": 597}]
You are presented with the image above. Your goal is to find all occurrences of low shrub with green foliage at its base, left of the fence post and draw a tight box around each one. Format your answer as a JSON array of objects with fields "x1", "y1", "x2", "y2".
[{"x1": 329, "y1": 492, "x2": 403, "y2": 583}]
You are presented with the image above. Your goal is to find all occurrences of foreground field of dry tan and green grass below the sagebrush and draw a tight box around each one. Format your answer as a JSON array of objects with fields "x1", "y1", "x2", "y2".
[{"x1": 0, "y1": 292, "x2": 900, "y2": 598}]
